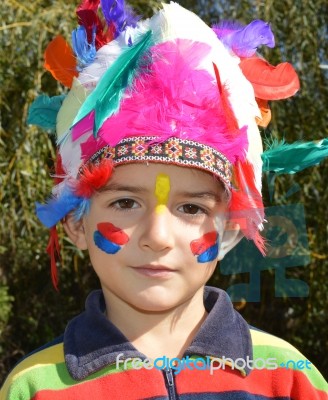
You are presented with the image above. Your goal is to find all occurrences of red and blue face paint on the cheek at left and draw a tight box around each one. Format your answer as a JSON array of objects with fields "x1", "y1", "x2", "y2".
[{"x1": 93, "y1": 222, "x2": 129, "y2": 254}]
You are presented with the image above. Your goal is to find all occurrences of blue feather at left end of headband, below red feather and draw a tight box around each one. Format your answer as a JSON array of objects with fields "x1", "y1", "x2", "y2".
[{"x1": 35, "y1": 189, "x2": 84, "y2": 228}]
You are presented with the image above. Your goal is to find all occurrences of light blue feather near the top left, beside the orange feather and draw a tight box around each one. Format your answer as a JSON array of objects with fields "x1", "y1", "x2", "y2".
[{"x1": 72, "y1": 26, "x2": 96, "y2": 70}]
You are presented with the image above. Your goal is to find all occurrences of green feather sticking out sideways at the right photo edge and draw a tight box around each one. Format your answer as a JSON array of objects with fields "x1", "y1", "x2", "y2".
[{"x1": 262, "y1": 138, "x2": 328, "y2": 175}]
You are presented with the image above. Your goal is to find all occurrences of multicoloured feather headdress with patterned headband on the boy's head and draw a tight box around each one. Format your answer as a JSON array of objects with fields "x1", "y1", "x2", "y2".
[{"x1": 29, "y1": 0, "x2": 299, "y2": 288}]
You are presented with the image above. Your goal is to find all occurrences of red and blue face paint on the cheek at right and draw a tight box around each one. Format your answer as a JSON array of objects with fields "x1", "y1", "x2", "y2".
[{"x1": 190, "y1": 231, "x2": 219, "y2": 263}]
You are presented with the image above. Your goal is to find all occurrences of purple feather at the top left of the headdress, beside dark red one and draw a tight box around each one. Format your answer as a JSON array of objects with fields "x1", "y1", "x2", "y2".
[{"x1": 101, "y1": 0, "x2": 139, "y2": 39}]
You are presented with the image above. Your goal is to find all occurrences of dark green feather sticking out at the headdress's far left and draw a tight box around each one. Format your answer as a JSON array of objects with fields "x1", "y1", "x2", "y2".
[{"x1": 27, "y1": 94, "x2": 66, "y2": 131}]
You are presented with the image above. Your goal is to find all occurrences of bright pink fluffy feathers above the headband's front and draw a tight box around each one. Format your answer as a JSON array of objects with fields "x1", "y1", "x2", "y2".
[{"x1": 73, "y1": 39, "x2": 248, "y2": 162}]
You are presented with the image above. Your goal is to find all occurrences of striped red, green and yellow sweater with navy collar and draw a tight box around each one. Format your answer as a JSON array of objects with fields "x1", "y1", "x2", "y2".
[{"x1": 0, "y1": 287, "x2": 328, "y2": 400}]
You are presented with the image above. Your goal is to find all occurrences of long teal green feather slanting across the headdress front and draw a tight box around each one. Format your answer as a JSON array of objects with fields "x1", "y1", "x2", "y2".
[{"x1": 73, "y1": 31, "x2": 152, "y2": 136}]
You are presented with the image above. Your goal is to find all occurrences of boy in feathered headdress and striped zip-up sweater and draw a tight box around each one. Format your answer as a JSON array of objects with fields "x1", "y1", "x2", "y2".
[{"x1": 0, "y1": 1, "x2": 327, "y2": 400}]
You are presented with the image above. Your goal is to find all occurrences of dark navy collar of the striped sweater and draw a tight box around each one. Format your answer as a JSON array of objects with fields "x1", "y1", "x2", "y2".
[{"x1": 64, "y1": 287, "x2": 252, "y2": 380}]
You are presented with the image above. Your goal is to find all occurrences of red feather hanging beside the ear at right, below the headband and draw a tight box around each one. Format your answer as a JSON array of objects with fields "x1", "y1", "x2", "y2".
[{"x1": 229, "y1": 160, "x2": 265, "y2": 255}]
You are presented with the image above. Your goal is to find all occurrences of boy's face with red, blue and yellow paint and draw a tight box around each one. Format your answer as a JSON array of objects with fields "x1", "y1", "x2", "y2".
[{"x1": 72, "y1": 163, "x2": 226, "y2": 311}]
